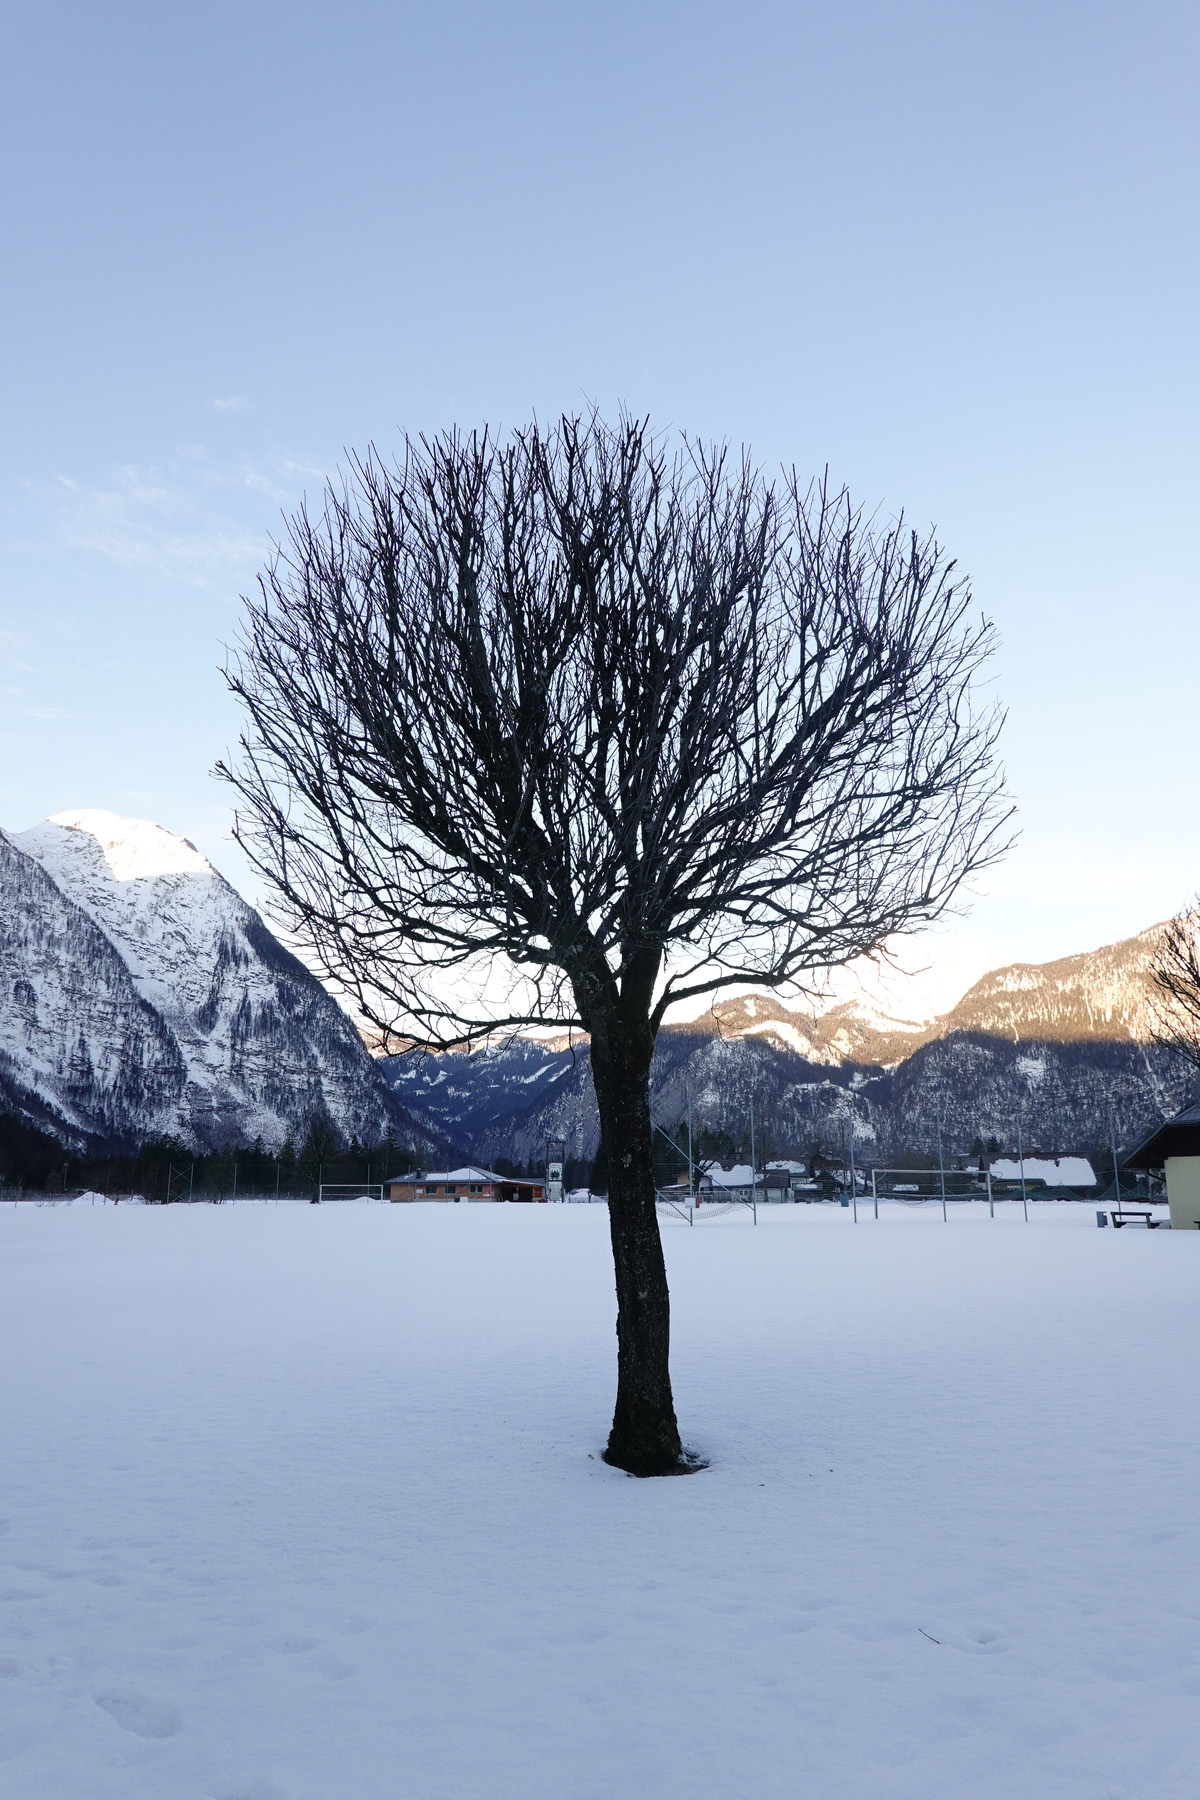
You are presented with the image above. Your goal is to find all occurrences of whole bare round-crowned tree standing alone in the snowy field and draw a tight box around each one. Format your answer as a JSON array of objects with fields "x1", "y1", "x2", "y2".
[{"x1": 218, "y1": 416, "x2": 1006, "y2": 1474}]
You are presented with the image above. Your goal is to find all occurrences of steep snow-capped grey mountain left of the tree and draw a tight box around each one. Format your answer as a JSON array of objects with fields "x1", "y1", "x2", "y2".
[{"x1": 0, "y1": 812, "x2": 407, "y2": 1148}]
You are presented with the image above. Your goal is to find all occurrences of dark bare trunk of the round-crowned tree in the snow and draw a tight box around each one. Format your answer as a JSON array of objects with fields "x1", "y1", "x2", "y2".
[{"x1": 588, "y1": 1004, "x2": 691, "y2": 1474}]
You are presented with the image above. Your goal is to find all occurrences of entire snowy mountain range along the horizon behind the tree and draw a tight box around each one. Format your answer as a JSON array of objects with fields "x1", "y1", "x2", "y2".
[{"x1": 0, "y1": 812, "x2": 1191, "y2": 1161}]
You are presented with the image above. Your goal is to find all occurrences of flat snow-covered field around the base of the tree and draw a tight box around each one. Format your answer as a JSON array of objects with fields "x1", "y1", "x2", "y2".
[{"x1": 0, "y1": 1204, "x2": 1200, "y2": 1800}]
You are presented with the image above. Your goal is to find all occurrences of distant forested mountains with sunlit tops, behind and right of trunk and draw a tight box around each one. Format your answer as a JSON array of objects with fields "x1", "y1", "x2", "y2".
[{"x1": 379, "y1": 927, "x2": 1191, "y2": 1161}]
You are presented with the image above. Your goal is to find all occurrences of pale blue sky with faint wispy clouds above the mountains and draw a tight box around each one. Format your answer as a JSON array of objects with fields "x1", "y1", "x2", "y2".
[{"x1": 0, "y1": 0, "x2": 1200, "y2": 959}]
